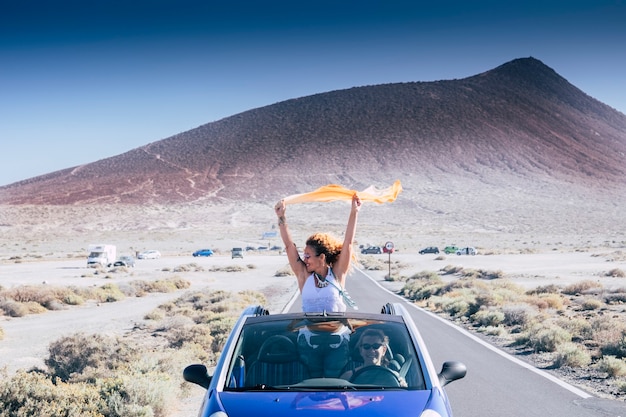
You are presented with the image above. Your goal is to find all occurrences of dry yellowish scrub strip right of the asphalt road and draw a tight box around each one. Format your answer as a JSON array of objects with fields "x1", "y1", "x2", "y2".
[{"x1": 401, "y1": 267, "x2": 626, "y2": 398}]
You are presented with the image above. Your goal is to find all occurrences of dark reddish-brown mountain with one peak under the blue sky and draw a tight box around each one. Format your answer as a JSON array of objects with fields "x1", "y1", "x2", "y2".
[{"x1": 0, "y1": 58, "x2": 626, "y2": 210}]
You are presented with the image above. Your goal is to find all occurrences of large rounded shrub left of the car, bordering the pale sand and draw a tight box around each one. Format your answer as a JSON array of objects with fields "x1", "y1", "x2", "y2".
[{"x1": 45, "y1": 333, "x2": 136, "y2": 381}]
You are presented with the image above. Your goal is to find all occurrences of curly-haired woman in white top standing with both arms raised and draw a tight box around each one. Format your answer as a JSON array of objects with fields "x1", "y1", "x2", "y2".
[{"x1": 274, "y1": 194, "x2": 361, "y2": 312}]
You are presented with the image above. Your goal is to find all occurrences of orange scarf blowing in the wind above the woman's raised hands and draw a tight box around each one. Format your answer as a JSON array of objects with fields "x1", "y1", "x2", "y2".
[{"x1": 284, "y1": 180, "x2": 402, "y2": 204}]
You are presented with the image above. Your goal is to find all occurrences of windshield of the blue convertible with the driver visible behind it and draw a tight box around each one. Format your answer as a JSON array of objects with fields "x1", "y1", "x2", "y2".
[{"x1": 224, "y1": 316, "x2": 425, "y2": 391}]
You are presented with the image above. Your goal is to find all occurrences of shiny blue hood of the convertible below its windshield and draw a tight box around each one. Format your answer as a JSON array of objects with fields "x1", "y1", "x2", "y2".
[{"x1": 220, "y1": 390, "x2": 431, "y2": 417}]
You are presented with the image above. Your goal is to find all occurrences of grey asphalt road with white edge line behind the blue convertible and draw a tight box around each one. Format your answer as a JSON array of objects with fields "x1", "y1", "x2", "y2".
[{"x1": 291, "y1": 270, "x2": 626, "y2": 417}]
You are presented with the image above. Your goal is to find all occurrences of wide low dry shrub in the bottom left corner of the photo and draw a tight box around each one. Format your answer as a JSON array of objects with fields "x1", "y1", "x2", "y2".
[{"x1": 0, "y1": 370, "x2": 106, "y2": 417}]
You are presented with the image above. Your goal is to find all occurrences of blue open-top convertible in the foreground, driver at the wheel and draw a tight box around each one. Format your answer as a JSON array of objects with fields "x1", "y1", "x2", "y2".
[{"x1": 183, "y1": 303, "x2": 467, "y2": 417}]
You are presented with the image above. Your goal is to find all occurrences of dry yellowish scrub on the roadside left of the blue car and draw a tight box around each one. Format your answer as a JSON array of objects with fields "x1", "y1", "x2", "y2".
[{"x1": 0, "y1": 291, "x2": 258, "y2": 417}]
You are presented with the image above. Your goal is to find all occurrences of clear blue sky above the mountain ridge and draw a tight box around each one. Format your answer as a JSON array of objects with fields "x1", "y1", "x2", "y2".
[{"x1": 0, "y1": 0, "x2": 626, "y2": 185}]
